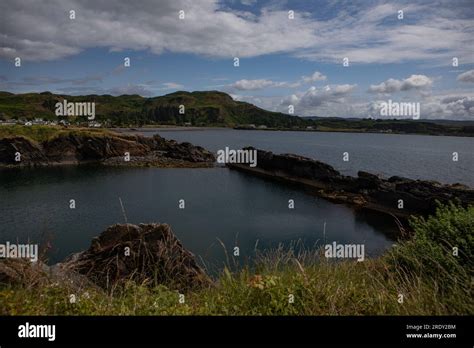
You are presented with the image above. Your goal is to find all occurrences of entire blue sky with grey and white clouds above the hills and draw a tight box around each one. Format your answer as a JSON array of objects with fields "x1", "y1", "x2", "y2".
[{"x1": 0, "y1": 0, "x2": 474, "y2": 120}]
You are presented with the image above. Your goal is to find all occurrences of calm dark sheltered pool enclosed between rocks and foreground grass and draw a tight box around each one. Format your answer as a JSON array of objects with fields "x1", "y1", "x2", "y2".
[{"x1": 0, "y1": 166, "x2": 394, "y2": 267}]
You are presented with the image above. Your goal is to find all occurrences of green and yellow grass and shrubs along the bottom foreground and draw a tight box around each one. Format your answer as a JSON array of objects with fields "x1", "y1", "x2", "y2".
[{"x1": 0, "y1": 204, "x2": 474, "y2": 315}]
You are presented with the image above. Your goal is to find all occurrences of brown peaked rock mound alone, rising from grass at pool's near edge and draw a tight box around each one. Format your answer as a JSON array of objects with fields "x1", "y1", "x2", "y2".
[{"x1": 61, "y1": 224, "x2": 209, "y2": 290}]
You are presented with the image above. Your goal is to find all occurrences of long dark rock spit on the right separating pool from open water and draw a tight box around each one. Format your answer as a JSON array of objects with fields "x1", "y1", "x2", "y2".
[{"x1": 228, "y1": 150, "x2": 474, "y2": 218}]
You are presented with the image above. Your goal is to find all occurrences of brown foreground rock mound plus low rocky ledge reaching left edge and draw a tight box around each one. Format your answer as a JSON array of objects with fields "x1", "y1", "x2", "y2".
[{"x1": 0, "y1": 224, "x2": 211, "y2": 292}]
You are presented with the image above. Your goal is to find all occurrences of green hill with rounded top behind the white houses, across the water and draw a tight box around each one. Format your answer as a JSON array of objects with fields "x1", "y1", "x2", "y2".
[{"x1": 0, "y1": 91, "x2": 308, "y2": 128}]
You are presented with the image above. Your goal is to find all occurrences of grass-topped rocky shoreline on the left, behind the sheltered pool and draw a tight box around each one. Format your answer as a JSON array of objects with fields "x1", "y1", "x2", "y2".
[{"x1": 0, "y1": 132, "x2": 215, "y2": 167}]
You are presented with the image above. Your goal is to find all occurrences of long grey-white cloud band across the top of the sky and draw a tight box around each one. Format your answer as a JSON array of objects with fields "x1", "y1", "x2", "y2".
[{"x1": 0, "y1": 0, "x2": 474, "y2": 64}]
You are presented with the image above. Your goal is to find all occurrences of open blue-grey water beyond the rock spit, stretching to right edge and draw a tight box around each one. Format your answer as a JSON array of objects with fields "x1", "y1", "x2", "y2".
[{"x1": 151, "y1": 129, "x2": 474, "y2": 187}]
